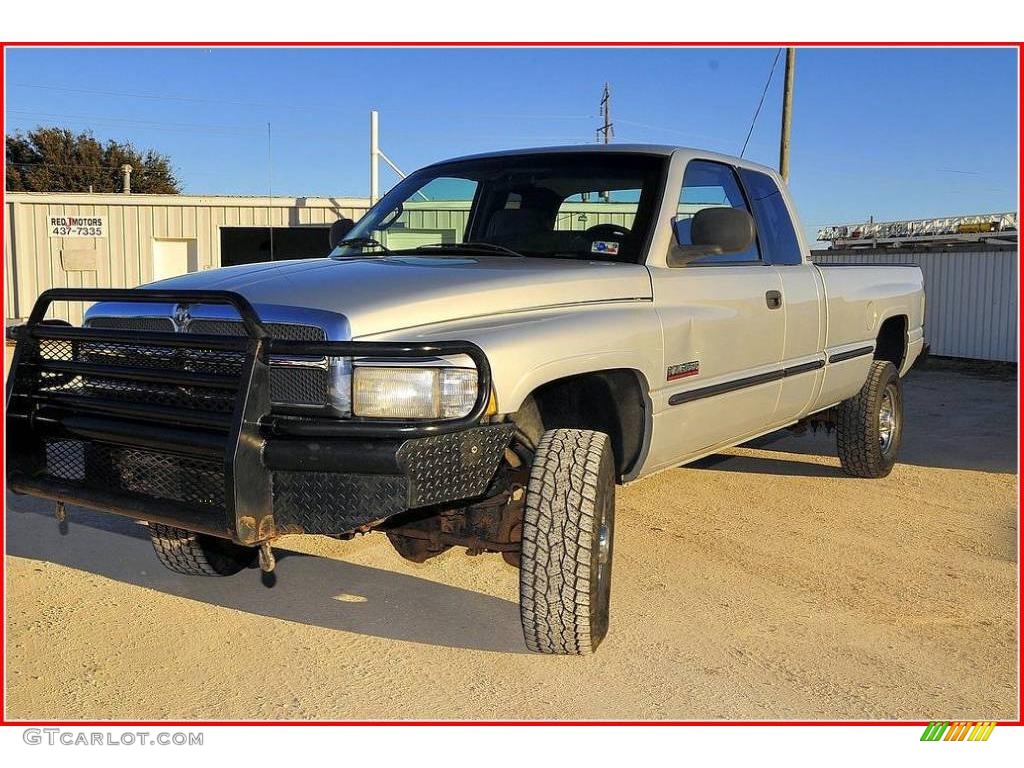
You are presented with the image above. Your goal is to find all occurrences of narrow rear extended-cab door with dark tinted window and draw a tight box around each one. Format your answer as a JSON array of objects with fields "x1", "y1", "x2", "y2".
[{"x1": 739, "y1": 168, "x2": 825, "y2": 422}]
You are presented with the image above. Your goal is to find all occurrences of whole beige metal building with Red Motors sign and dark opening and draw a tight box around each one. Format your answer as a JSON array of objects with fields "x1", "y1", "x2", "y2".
[{"x1": 4, "y1": 193, "x2": 369, "y2": 325}]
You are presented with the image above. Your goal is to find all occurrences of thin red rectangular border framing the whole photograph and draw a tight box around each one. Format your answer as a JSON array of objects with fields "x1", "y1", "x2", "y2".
[{"x1": 0, "y1": 41, "x2": 1024, "y2": 727}]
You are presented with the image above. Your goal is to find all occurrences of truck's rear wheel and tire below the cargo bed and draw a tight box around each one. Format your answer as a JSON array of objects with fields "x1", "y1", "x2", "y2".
[{"x1": 836, "y1": 360, "x2": 903, "y2": 477}]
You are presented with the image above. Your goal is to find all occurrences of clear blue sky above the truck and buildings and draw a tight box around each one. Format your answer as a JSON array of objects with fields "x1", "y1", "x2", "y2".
[{"x1": 6, "y1": 48, "x2": 1018, "y2": 243}]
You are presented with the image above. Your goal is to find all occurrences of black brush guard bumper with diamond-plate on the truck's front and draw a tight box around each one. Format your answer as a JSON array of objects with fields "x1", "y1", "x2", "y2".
[{"x1": 6, "y1": 289, "x2": 512, "y2": 545}]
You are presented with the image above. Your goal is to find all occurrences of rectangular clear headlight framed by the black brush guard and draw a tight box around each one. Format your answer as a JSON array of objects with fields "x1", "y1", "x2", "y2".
[{"x1": 352, "y1": 366, "x2": 476, "y2": 419}]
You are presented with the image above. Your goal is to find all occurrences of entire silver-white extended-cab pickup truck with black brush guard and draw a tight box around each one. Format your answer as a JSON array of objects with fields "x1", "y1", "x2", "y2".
[{"x1": 6, "y1": 145, "x2": 925, "y2": 653}]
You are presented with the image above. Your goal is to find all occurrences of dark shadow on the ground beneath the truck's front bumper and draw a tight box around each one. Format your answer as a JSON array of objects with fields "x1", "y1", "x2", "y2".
[{"x1": 6, "y1": 495, "x2": 527, "y2": 653}]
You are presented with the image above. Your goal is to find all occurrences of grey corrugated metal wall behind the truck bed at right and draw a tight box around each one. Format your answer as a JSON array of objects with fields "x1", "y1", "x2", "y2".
[{"x1": 813, "y1": 246, "x2": 1020, "y2": 362}]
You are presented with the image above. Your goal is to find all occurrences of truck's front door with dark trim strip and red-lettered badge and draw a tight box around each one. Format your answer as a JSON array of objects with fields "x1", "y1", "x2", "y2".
[{"x1": 650, "y1": 160, "x2": 785, "y2": 466}]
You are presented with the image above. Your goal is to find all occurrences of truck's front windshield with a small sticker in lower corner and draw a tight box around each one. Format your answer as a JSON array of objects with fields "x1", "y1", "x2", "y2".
[{"x1": 331, "y1": 152, "x2": 668, "y2": 263}]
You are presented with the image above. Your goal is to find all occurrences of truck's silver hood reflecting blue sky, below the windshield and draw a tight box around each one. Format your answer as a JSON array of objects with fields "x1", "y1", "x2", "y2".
[{"x1": 144, "y1": 255, "x2": 652, "y2": 338}]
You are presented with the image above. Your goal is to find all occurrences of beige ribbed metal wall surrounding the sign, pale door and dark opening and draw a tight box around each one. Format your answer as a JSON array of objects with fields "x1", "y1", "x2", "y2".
[{"x1": 4, "y1": 193, "x2": 369, "y2": 323}]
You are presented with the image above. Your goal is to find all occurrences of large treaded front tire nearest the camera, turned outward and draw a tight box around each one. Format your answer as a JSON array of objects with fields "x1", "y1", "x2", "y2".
[{"x1": 519, "y1": 429, "x2": 615, "y2": 654}]
